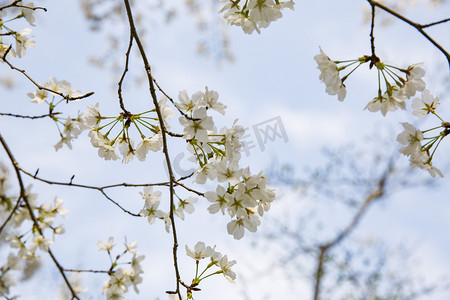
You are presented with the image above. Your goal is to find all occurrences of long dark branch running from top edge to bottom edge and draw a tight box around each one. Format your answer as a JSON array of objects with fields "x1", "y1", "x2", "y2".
[{"x1": 124, "y1": 0, "x2": 181, "y2": 298}]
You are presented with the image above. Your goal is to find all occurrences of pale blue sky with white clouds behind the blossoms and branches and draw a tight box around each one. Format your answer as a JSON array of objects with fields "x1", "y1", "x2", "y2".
[{"x1": 0, "y1": 1, "x2": 450, "y2": 300}]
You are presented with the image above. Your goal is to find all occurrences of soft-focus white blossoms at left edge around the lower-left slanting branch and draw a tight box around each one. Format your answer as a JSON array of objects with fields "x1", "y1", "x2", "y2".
[{"x1": 0, "y1": 163, "x2": 68, "y2": 299}]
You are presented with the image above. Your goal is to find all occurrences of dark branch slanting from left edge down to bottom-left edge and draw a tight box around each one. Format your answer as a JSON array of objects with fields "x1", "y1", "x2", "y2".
[{"x1": 0, "y1": 134, "x2": 80, "y2": 300}]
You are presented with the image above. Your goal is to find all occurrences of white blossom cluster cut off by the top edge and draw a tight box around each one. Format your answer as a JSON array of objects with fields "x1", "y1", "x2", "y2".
[{"x1": 219, "y1": 0, "x2": 294, "y2": 34}]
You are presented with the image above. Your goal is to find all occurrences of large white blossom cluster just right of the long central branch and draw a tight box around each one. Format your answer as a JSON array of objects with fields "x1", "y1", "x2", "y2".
[{"x1": 176, "y1": 88, "x2": 275, "y2": 239}]
